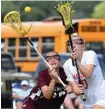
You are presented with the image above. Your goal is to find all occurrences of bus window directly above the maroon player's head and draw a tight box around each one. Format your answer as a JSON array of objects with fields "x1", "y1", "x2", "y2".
[{"x1": 42, "y1": 37, "x2": 54, "y2": 53}]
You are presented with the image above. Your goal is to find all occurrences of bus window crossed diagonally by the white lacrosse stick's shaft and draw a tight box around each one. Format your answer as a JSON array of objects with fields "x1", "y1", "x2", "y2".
[{"x1": 30, "y1": 38, "x2": 38, "y2": 58}]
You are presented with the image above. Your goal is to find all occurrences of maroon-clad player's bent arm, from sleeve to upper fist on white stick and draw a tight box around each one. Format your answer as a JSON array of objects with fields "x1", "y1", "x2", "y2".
[{"x1": 38, "y1": 69, "x2": 58, "y2": 99}]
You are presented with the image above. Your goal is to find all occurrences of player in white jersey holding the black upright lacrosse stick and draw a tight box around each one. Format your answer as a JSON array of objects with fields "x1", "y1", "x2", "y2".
[{"x1": 63, "y1": 33, "x2": 105, "y2": 109}]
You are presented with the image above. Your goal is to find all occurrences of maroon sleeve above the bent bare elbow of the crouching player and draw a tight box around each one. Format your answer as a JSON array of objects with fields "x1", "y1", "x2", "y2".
[{"x1": 38, "y1": 71, "x2": 47, "y2": 88}]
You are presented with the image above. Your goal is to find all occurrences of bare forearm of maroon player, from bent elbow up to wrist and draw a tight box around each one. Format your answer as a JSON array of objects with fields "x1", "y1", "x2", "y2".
[{"x1": 43, "y1": 79, "x2": 55, "y2": 99}]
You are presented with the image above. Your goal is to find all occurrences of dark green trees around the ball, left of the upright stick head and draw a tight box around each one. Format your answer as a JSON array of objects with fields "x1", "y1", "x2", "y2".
[{"x1": 1, "y1": 1, "x2": 56, "y2": 22}]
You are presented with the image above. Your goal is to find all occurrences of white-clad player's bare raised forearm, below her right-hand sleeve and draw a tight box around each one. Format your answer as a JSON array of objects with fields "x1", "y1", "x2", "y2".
[{"x1": 76, "y1": 60, "x2": 91, "y2": 79}]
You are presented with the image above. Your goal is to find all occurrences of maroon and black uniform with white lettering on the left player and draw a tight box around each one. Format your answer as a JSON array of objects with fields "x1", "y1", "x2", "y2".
[{"x1": 23, "y1": 68, "x2": 67, "y2": 109}]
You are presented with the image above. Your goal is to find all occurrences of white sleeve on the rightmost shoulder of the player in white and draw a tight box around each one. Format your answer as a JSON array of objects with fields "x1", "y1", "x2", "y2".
[{"x1": 85, "y1": 50, "x2": 98, "y2": 65}]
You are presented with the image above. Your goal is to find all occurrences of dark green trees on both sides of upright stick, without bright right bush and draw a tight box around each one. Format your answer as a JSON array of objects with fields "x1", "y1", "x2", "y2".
[{"x1": 1, "y1": 1, "x2": 100, "y2": 22}]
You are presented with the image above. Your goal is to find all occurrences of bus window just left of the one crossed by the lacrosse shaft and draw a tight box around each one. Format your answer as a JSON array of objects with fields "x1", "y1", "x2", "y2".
[{"x1": 19, "y1": 38, "x2": 27, "y2": 58}]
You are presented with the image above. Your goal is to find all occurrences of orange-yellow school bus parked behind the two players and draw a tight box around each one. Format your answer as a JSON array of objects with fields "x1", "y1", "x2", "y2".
[{"x1": 1, "y1": 19, "x2": 105, "y2": 72}]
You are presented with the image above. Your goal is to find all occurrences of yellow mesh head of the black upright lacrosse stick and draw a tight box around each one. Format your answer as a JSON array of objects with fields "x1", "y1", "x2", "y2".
[{"x1": 55, "y1": 1, "x2": 73, "y2": 30}]
